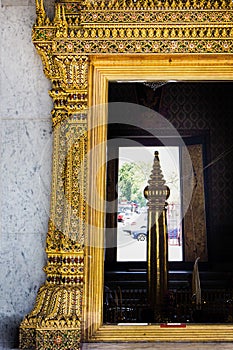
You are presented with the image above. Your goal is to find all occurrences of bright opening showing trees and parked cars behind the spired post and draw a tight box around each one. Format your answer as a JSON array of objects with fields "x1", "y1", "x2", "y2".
[{"x1": 117, "y1": 146, "x2": 183, "y2": 261}]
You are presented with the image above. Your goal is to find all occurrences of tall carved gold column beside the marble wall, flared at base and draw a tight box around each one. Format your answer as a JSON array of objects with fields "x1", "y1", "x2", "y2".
[{"x1": 20, "y1": 0, "x2": 89, "y2": 349}]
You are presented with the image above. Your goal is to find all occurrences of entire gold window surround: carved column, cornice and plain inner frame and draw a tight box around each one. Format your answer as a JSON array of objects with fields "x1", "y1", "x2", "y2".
[{"x1": 20, "y1": 0, "x2": 233, "y2": 350}]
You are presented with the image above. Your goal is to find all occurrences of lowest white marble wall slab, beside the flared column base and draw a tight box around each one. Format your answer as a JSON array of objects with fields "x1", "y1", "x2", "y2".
[{"x1": 0, "y1": 232, "x2": 46, "y2": 349}]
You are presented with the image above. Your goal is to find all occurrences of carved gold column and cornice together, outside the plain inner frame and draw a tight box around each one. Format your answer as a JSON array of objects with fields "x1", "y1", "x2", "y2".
[{"x1": 20, "y1": 0, "x2": 233, "y2": 350}]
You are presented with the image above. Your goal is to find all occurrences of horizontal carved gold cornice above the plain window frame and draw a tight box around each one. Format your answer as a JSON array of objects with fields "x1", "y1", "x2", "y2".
[{"x1": 33, "y1": 0, "x2": 233, "y2": 55}]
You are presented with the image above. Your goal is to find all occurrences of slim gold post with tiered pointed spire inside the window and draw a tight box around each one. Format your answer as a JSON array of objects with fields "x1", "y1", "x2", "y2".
[{"x1": 145, "y1": 152, "x2": 169, "y2": 322}]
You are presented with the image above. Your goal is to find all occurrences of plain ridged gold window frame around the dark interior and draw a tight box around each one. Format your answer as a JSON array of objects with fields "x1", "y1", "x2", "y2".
[{"x1": 83, "y1": 54, "x2": 233, "y2": 342}]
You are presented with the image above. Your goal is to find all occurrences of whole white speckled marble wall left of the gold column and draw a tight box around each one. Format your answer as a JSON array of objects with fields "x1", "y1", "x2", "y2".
[{"x1": 0, "y1": 0, "x2": 54, "y2": 350}]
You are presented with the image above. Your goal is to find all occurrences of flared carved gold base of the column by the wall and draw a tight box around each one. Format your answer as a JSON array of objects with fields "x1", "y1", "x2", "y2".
[{"x1": 20, "y1": 284, "x2": 82, "y2": 349}]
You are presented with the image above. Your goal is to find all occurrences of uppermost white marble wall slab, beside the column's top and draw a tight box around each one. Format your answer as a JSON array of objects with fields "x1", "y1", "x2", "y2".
[{"x1": 0, "y1": 6, "x2": 52, "y2": 119}]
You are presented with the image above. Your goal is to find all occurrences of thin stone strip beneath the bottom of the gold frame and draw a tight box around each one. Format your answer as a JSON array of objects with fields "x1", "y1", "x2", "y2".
[{"x1": 82, "y1": 343, "x2": 233, "y2": 350}]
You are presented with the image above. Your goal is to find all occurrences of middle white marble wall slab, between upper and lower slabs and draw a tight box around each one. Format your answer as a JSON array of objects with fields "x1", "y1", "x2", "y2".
[{"x1": 1, "y1": 119, "x2": 53, "y2": 234}]
